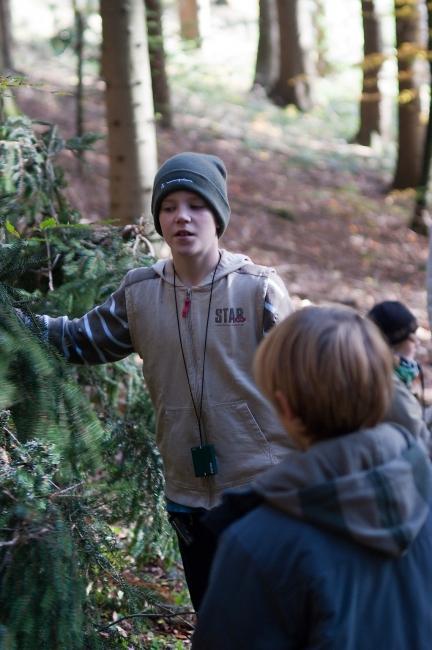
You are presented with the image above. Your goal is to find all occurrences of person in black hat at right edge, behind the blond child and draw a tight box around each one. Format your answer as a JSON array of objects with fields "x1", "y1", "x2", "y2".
[{"x1": 367, "y1": 300, "x2": 432, "y2": 455}]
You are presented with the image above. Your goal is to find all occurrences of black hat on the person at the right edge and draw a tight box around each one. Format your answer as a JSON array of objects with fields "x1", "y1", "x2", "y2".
[{"x1": 367, "y1": 300, "x2": 418, "y2": 345}]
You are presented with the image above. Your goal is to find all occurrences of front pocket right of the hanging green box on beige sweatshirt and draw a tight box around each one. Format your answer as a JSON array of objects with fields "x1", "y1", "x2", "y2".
[{"x1": 205, "y1": 401, "x2": 272, "y2": 488}]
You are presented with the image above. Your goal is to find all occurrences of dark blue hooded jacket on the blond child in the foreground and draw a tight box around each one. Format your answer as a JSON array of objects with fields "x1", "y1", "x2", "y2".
[{"x1": 193, "y1": 425, "x2": 432, "y2": 650}]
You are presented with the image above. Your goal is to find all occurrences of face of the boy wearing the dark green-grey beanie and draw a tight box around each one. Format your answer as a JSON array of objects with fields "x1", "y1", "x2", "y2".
[{"x1": 159, "y1": 190, "x2": 219, "y2": 257}]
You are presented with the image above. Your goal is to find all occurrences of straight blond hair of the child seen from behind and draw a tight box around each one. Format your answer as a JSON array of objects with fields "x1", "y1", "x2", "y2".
[{"x1": 254, "y1": 307, "x2": 393, "y2": 440}]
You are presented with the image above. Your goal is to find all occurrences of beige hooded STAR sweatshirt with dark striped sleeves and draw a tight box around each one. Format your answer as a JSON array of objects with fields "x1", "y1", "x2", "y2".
[{"x1": 44, "y1": 251, "x2": 292, "y2": 508}]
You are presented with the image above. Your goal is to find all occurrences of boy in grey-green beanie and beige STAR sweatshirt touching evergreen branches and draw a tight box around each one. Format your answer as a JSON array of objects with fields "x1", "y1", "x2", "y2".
[{"x1": 22, "y1": 152, "x2": 292, "y2": 610}]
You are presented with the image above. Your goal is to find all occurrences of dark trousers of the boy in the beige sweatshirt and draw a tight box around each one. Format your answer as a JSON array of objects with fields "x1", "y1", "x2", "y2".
[{"x1": 168, "y1": 509, "x2": 217, "y2": 612}]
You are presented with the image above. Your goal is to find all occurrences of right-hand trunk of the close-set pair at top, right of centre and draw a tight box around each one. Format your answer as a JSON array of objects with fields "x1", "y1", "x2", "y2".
[{"x1": 268, "y1": 0, "x2": 311, "y2": 111}]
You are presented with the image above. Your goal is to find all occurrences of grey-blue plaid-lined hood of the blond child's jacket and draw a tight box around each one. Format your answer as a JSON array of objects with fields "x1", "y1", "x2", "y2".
[{"x1": 253, "y1": 423, "x2": 432, "y2": 556}]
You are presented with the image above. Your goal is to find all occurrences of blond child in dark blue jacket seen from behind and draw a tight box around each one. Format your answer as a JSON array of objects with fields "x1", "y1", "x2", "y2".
[{"x1": 193, "y1": 307, "x2": 432, "y2": 650}]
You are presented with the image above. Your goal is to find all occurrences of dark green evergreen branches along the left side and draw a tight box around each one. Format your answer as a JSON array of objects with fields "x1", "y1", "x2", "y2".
[{"x1": 0, "y1": 117, "x2": 172, "y2": 650}]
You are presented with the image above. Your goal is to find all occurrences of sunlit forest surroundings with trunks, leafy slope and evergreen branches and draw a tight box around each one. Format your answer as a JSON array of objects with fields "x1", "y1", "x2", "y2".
[{"x1": 0, "y1": 0, "x2": 432, "y2": 650}]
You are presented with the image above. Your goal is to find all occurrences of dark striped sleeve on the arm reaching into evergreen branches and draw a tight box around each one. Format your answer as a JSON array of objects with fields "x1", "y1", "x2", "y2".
[{"x1": 42, "y1": 285, "x2": 133, "y2": 364}]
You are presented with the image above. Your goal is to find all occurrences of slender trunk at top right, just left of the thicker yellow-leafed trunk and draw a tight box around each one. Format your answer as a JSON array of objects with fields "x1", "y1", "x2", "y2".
[{"x1": 354, "y1": 0, "x2": 383, "y2": 147}]
